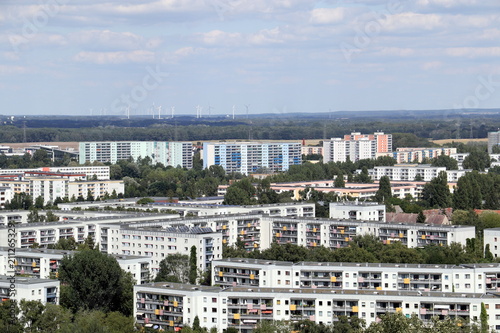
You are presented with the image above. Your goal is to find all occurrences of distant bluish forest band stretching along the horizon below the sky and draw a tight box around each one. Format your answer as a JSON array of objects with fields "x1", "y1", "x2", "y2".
[{"x1": 0, "y1": 111, "x2": 500, "y2": 144}]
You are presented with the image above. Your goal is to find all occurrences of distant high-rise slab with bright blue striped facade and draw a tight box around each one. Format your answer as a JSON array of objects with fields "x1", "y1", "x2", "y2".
[{"x1": 203, "y1": 142, "x2": 302, "y2": 175}]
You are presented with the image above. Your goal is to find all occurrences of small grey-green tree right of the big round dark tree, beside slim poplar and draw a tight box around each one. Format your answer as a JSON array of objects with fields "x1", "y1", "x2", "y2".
[{"x1": 155, "y1": 253, "x2": 189, "y2": 283}]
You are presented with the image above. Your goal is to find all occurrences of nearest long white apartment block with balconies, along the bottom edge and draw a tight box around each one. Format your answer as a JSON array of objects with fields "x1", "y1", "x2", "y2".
[{"x1": 134, "y1": 283, "x2": 500, "y2": 333}]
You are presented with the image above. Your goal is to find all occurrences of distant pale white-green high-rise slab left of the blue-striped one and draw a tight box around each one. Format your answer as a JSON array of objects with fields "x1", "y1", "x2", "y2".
[{"x1": 79, "y1": 141, "x2": 193, "y2": 168}]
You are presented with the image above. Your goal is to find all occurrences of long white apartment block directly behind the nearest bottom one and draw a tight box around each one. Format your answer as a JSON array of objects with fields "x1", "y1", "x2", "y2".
[{"x1": 212, "y1": 258, "x2": 500, "y2": 294}]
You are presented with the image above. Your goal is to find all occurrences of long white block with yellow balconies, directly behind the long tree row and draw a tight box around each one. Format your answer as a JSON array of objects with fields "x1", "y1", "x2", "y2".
[{"x1": 127, "y1": 214, "x2": 475, "y2": 251}]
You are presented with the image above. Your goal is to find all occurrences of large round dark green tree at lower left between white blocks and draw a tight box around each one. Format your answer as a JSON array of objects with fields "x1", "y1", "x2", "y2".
[{"x1": 59, "y1": 250, "x2": 129, "y2": 315}]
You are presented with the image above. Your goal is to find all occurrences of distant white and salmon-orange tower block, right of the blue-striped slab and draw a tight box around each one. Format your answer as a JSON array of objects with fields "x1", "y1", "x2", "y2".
[{"x1": 323, "y1": 132, "x2": 392, "y2": 163}]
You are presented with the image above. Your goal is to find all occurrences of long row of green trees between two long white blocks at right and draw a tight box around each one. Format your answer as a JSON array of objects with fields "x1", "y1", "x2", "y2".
[{"x1": 226, "y1": 235, "x2": 494, "y2": 265}]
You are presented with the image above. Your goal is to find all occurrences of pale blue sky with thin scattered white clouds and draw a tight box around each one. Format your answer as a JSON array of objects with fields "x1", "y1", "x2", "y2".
[{"x1": 0, "y1": 0, "x2": 500, "y2": 117}]
